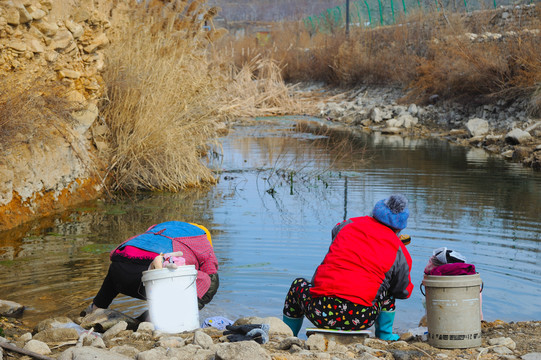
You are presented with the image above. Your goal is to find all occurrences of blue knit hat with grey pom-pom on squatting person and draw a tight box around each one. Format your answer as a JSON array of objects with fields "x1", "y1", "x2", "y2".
[{"x1": 372, "y1": 194, "x2": 410, "y2": 230}]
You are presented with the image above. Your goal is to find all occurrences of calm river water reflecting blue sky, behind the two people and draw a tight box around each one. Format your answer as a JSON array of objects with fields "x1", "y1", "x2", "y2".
[{"x1": 0, "y1": 118, "x2": 541, "y2": 330}]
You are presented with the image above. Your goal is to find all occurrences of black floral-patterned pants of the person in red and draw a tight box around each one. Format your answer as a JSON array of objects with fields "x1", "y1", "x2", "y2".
[{"x1": 283, "y1": 278, "x2": 395, "y2": 330}]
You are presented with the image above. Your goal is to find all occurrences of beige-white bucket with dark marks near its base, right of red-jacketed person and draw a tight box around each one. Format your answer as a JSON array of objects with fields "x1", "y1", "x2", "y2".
[{"x1": 421, "y1": 274, "x2": 482, "y2": 349}]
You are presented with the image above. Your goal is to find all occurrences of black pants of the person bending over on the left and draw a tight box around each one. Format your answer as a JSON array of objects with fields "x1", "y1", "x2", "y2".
[{"x1": 93, "y1": 261, "x2": 148, "y2": 309}]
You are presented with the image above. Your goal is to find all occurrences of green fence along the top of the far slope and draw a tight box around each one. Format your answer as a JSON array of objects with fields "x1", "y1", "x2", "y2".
[{"x1": 303, "y1": 0, "x2": 539, "y2": 34}]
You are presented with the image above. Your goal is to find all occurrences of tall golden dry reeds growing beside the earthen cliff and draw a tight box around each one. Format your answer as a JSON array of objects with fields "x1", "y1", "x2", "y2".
[{"x1": 102, "y1": 1, "x2": 226, "y2": 191}]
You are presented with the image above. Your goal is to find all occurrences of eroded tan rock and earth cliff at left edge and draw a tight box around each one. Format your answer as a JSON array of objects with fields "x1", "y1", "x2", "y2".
[{"x1": 0, "y1": 0, "x2": 112, "y2": 231}]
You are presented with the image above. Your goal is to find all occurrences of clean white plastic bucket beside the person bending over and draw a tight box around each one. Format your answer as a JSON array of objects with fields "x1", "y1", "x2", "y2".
[{"x1": 142, "y1": 265, "x2": 199, "y2": 333}]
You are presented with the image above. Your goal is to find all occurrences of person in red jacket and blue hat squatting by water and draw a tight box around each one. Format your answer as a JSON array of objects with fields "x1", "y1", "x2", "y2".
[{"x1": 283, "y1": 195, "x2": 413, "y2": 340}]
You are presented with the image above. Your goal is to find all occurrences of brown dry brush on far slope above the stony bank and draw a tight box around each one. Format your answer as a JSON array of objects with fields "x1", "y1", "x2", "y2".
[{"x1": 217, "y1": 6, "x2": 541, "y2": 112}]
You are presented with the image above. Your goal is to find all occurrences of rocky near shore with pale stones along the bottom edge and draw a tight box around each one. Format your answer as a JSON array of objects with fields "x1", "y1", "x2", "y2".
[{"x1": 0, "y1": 304, "x2": 541, "y2": 360}]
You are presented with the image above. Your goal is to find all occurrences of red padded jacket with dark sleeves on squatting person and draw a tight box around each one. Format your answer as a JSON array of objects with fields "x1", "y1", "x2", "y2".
[{"x1": 310, "y1": 216, "x2": 413, "y2": 306}]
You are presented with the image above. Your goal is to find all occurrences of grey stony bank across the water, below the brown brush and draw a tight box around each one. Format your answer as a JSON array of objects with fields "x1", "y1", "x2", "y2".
[{"x1": 312, "y1": 87, "x2": 541, "y2": 170}]
